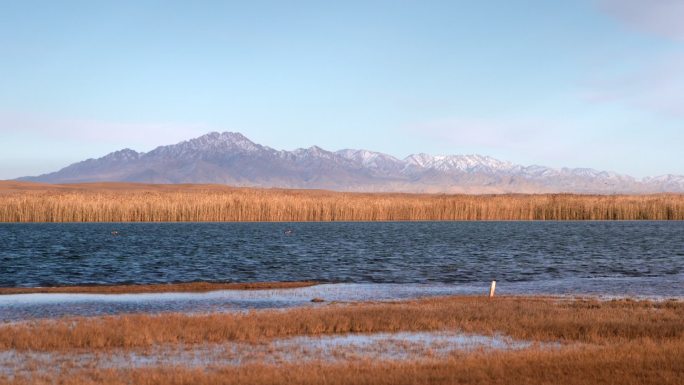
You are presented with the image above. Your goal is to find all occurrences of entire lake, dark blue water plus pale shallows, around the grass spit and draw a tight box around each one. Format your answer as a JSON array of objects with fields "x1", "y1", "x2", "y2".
[{"x1": 0, "y1": 222, "x2": 684, "y2": 320}]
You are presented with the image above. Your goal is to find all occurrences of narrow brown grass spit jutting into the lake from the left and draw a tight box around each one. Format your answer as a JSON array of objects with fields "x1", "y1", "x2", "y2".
[{"x1": 0, "y1": 282, "x2": 317, "y2": 295}]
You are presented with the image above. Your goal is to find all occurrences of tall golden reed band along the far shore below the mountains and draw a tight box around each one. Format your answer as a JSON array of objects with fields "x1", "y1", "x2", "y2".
[{"x1": 0, "y1": 182, "x2": 684, "y2": 222}]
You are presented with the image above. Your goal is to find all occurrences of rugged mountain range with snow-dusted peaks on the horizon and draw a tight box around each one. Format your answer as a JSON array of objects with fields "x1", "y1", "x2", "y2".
[{"x1": 19, "y1": 132, "x2": 684, "y2": 194}]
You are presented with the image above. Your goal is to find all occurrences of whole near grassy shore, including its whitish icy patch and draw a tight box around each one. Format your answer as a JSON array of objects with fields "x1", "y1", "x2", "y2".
[{"x1": 0, "y1": 296, "x2": 684, "y2": 384}]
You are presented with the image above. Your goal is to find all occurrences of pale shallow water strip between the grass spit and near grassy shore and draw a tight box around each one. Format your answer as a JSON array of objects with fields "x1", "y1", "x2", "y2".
[{"x1": 0, "y1": 276, "x2": 684, "y2": 321}]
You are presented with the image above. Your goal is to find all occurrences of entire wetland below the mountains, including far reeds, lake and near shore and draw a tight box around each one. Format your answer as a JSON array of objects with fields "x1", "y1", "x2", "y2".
[{"x1": 0, "y1": 182, "x2": 684, "y2": 384}]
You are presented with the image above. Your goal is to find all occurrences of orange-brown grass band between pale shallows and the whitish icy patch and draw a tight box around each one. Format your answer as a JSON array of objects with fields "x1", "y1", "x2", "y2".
[{"x1": 0, "y1": 297, "x2": 684, "y2": 351}]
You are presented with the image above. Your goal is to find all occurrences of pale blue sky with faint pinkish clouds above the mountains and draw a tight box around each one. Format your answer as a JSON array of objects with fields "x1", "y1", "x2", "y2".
[{"x1": 0, "y1": 0, "x2": 684, "y2": 179}]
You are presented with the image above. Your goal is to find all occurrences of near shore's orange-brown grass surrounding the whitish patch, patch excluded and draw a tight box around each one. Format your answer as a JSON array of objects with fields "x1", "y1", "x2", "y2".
[{"x1": 0, "y1": 297, "x2": 684, "y2": 384}]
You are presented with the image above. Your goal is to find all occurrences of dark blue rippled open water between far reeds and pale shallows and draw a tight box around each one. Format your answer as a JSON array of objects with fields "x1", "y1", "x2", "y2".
[{"x1": 0, "y1": 222, "x2": 684, "y2": 287}]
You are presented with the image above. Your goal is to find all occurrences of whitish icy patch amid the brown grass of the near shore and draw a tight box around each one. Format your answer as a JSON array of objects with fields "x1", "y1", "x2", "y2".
[{"x1": 0, "y1": 331, "x2": 540, "y2": 376}]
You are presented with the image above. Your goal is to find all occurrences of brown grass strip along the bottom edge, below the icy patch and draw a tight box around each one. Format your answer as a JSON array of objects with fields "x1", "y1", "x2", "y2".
[{"x1": 6, "y1": 340, "x2": 684, "y2": 385}]
